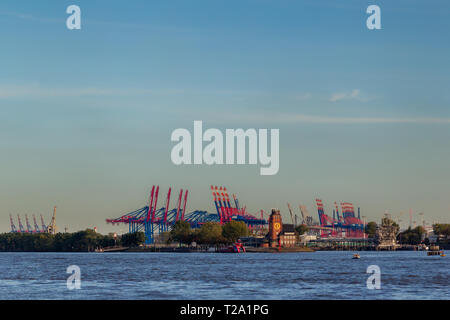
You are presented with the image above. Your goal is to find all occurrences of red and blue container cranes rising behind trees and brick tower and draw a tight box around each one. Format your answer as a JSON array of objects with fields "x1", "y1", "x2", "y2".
[{"x1": 106, "y1": 186, "x2": 366, "y2": 247}]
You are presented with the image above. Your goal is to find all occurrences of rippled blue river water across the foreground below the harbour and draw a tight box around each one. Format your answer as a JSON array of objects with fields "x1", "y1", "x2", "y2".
[{"x1": 0, "y1": 251, "x2": 450, "y2": 300}]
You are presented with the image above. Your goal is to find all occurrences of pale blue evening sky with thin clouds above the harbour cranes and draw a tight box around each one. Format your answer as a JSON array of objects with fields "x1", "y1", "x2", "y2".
[{"x1": 0, "y1": 0, "x2": 450, "y2": 233}]
